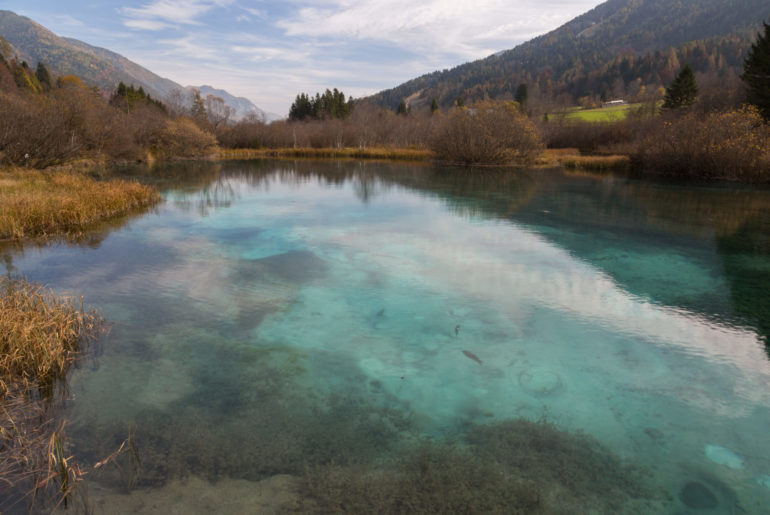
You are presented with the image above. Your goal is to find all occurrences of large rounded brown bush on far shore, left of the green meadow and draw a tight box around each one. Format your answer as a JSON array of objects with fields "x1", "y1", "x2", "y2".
[{"x1": 431, "y1": 102, "x2": 543, "y2": 164}]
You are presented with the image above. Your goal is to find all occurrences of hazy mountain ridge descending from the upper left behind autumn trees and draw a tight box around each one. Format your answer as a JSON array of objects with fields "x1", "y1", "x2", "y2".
[{"x1": 0, "y1": 10, "x2": 268, "y2": 119}]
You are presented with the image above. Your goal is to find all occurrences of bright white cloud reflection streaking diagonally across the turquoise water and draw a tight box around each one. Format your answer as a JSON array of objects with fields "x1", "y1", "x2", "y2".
[{"x1": 306, "y1": 215, "x2": 770, "y2": 412}]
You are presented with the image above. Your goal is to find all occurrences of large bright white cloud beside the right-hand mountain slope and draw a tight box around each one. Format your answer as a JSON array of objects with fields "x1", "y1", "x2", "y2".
[{"x1": 277, "y1": 0, "x2": 596, "y2": 58}]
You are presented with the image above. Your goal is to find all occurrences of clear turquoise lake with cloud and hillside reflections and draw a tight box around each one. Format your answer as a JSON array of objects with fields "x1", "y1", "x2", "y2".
[{"x1": 5, "y1": 161, "x2": 770, "y2": 513}]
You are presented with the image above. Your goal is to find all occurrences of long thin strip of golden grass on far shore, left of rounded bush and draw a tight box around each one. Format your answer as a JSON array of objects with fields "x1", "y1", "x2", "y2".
[{"x1": 219, "y1": 147, "x2": 435, "y2": 161}]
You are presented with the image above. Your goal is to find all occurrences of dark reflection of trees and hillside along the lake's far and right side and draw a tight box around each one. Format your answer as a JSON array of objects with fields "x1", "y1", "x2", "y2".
[{"x1": 118, "y1": 159, "x2": 770, "y2": 358}]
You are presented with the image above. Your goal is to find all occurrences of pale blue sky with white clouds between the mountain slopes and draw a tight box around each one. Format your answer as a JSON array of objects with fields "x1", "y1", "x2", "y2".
[{"x1": 0, "y1": 0, "x2": 600, "y2": 115}]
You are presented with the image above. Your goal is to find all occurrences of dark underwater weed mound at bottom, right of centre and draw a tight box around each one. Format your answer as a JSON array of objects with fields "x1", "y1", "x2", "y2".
[{"x1": 304, "y1": 419, "x2": 660, "y2": 513}]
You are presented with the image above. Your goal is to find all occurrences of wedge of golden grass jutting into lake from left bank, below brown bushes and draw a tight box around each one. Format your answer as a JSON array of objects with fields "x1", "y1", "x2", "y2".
[{"x1": 0, "y1": 169, "x2": 160, "y2": 241}]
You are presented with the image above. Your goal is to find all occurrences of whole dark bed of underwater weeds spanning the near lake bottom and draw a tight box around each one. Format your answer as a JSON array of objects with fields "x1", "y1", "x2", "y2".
[{"x1": 75, "y1": 336, "x2": 661, "y2": 514}]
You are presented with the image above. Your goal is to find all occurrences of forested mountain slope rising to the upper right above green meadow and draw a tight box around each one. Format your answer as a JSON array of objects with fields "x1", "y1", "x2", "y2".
[{"x1": 370, "y1": 0, "x2": 770, "y2": 109}]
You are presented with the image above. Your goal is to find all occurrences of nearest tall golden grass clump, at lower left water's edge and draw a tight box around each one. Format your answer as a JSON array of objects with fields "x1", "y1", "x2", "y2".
[{"x1": 0, "y1": 278, "x2": 102, "y2": 509}]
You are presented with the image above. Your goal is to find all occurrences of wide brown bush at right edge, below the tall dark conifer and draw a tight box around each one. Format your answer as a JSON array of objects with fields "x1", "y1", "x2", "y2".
[{"x1": 631, "y1": 108, "x2": 770, "y2": 182}]
